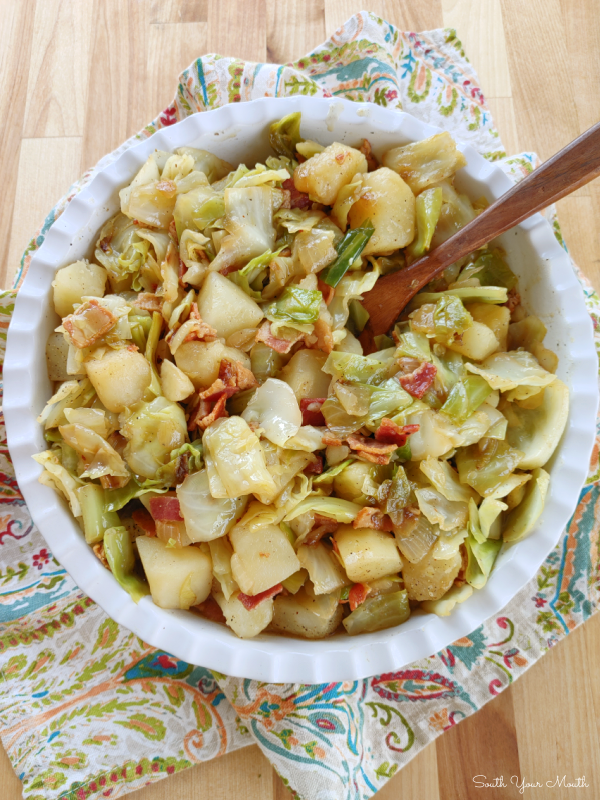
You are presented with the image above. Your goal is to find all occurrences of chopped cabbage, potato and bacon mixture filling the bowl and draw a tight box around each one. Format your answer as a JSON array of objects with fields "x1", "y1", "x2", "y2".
[{"x1": 35, "y1": 114, "x2": 569, "y2": 639}]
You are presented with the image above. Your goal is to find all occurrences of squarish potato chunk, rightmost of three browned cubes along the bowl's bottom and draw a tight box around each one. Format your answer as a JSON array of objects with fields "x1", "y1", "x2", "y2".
[{"x1": 334, "y1": 525, "x2": 402, "y2": 583}]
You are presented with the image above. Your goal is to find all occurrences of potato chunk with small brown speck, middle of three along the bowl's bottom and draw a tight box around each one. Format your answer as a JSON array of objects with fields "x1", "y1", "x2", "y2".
[{"x1": 229, "y1": 525, "x2": 300, "y2": 595}]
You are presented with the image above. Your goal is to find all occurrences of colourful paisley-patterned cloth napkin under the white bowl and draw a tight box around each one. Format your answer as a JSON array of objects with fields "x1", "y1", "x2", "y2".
[{"x1": 0, "y1": 12, "x2": 600, "y2": 800}]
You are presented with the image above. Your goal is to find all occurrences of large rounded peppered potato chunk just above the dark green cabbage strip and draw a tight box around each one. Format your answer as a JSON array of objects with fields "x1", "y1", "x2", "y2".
[{"x1": 348, "y1": 167, "x2": 417, "y2": 256}]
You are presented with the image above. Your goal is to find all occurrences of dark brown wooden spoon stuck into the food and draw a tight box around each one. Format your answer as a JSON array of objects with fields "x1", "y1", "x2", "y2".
[{"x1": 360, "y1": 122, "x2": 600, "y2": 346}]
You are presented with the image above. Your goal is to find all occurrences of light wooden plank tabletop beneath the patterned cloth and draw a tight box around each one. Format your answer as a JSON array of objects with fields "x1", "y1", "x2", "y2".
[{"x1": 0, "y1": 0, "x2": 600, "y2": 800}]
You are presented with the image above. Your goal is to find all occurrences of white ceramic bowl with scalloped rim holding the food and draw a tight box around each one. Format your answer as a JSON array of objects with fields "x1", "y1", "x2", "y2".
[{"x1": 4, "y1": 97, "x2": 598, "y2": 683}]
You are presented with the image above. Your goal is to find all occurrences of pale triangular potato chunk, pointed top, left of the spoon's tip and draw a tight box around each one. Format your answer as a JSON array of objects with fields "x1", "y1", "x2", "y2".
[{"x1": 198, "y1": 272, "x2": 263, "y2": 339}]
